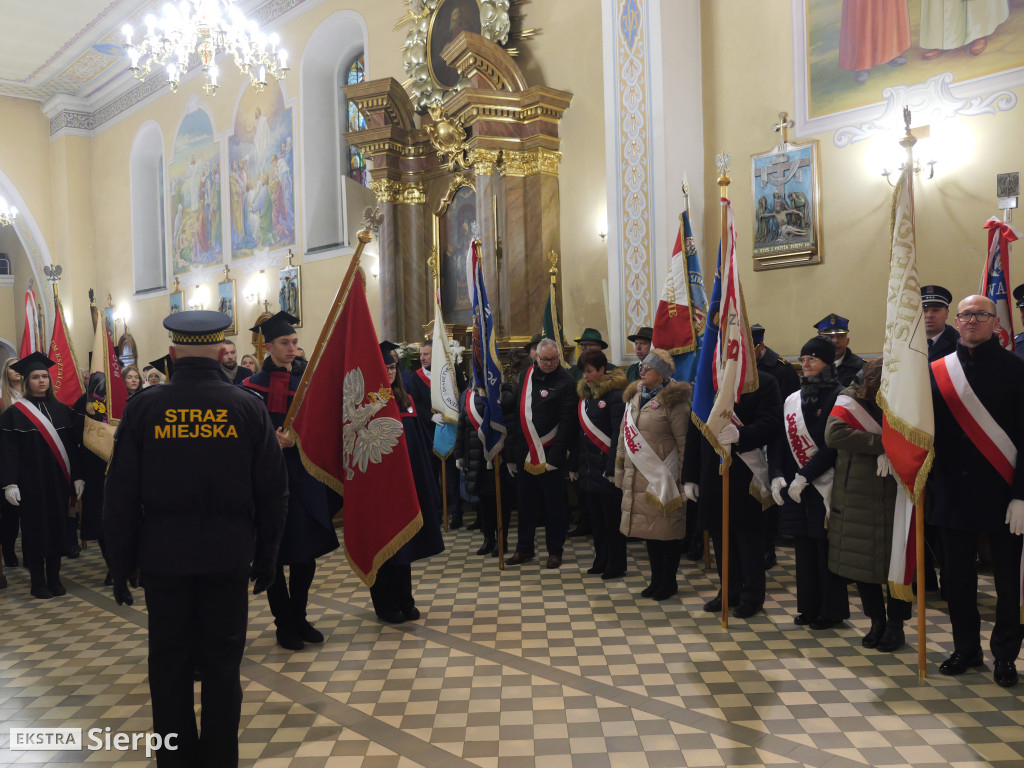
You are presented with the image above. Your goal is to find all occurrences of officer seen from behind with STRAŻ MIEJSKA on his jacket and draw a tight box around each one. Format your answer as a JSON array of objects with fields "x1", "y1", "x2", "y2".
[{"x1": 103, "y1": 311, "x2": 288, "y2": 768}]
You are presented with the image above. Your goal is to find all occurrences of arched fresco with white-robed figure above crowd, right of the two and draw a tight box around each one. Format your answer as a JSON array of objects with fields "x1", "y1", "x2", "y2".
[{"x1": 227, "y1": 82, "x2": 295, "y2": 260}]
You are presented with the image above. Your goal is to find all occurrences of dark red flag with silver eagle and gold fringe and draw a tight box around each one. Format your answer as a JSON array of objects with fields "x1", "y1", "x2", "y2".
[{"x1": 285, "y1": 258, "x2": 423, "y2": 586}]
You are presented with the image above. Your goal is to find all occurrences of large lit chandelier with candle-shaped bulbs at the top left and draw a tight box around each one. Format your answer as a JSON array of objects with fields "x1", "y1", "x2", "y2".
[{"x1": 121, "y1": 0, "x2": 288, "y2": 94}]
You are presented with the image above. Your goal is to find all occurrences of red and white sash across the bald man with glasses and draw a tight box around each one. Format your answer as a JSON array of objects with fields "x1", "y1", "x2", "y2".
[{"x1": 932, "y1": 352, "x2": 1017, "y2": 485}]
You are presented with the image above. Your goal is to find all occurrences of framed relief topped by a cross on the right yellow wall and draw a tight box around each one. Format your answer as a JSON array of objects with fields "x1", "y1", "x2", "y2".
[{"x1": 751, "y1": 140, "x2": 823, "y2": 271}]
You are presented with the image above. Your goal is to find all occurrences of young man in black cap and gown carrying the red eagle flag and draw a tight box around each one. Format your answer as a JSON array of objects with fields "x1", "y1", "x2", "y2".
[{"x1": 242, "y1": 312, "x2": 338, "y2": 650}]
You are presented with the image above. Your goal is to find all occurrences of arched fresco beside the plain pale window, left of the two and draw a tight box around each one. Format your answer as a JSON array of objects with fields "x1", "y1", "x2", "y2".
[{"x1": 168, "y1": 109, "x2": 224, "y2": 275}]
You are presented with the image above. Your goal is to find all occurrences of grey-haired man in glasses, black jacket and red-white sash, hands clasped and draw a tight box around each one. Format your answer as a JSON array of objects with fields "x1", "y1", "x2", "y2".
[{"x1": 508, "y1": 339, "x2": 578, "y2": 568}]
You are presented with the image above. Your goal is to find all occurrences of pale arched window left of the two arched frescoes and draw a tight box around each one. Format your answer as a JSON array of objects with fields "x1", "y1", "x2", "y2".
[{"x1": 129, "y1": 122, "x2": 167, "y2": 294}]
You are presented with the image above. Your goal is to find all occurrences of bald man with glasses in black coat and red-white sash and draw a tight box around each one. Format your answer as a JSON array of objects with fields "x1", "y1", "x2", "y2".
[{"x1": 927, "y1": 296, "x2": 1024, "y2": 687}]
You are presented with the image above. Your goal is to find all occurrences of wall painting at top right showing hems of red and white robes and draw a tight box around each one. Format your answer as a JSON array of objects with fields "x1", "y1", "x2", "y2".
[{"x1": 794, "y1": 0, "x2": 1024, "y2": 120}]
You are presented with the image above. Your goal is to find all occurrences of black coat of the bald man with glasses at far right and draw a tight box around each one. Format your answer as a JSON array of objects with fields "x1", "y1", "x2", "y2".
[{"x1": 928, "y1": 337, "x2": 1024, "y2": 530}]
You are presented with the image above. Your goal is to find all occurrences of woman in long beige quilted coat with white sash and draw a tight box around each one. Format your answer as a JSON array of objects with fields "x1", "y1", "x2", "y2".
[{"x1": 615, "y1": 349, "x2": 692, "y2": 600}]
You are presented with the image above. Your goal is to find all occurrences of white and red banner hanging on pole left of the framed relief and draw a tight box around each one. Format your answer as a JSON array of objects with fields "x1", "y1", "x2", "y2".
[{"x1": 705, "y1": 198, "x2": 758, "y2": 465}]
